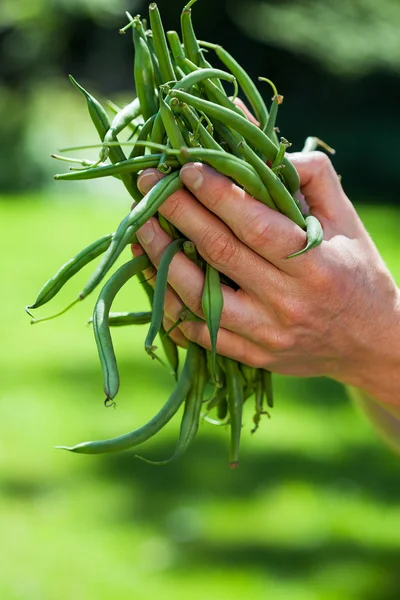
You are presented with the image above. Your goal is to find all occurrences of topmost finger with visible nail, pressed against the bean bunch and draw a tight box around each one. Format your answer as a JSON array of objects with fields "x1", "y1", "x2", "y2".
[{"x1": 178, "y1": 163, "x2": 308, "y2": 274}]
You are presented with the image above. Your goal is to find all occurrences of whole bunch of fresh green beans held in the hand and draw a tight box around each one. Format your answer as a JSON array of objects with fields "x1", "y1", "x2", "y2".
[{"x1": 27, "y1": 0, "x2": 323, "y2": 468}]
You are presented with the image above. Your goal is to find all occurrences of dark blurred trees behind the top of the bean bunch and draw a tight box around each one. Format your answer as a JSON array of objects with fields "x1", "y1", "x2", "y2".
[{"x1": 0, "y1": 0, "x2": 400, "y2": 201}]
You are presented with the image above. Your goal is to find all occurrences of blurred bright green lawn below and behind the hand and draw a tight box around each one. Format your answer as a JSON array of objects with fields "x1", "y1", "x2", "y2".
[{"x1": 0, "y1": 196, "x2": 400, "y2": 600}]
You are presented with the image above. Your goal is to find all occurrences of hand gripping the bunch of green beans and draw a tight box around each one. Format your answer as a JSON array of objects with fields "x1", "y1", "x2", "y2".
[{"x1": 133, "y1": 152, "x2": 400, "y2": 404}]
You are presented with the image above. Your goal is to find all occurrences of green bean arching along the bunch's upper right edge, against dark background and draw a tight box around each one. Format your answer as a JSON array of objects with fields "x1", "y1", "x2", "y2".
[{"x1": 199, "y1": 42, "x2": 268, "y2": 129}]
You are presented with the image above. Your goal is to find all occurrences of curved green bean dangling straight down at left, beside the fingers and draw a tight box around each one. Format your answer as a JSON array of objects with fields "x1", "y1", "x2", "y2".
[{"x1": 93, "y1": 254, "x2": 151, "y2": 401}]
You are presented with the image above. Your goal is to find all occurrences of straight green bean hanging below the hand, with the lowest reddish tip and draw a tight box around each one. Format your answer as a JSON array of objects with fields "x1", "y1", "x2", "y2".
[{"x1": 224, "y1": 358, "x2": 243, "y2": 469}]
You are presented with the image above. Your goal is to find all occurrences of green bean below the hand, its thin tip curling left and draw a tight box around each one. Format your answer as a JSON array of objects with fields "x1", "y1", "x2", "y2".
[{"x1": 136, "y1": 348, "x2": 208, "y2": 465}]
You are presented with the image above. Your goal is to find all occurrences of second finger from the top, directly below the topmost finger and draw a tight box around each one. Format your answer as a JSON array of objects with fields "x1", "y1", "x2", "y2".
[{"x1": 138, "y1": 166, "x2": 275, "y2": 295}]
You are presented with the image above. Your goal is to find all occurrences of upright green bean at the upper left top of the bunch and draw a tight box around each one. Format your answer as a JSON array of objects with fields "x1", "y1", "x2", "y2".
[{"x1": 132, "y1": 17, "x2": 157, "y2": 121}]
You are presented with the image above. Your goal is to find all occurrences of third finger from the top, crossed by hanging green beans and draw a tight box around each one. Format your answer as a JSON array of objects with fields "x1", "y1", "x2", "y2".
[{"x1": 137, "y1": 211, "x2": 260, "y2": 331}]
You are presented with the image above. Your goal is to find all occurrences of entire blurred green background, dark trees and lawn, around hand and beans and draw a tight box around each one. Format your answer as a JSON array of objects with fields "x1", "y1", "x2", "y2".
[{"x1": 0, "y1": 0, "x2": 400, "y2": 600}]
